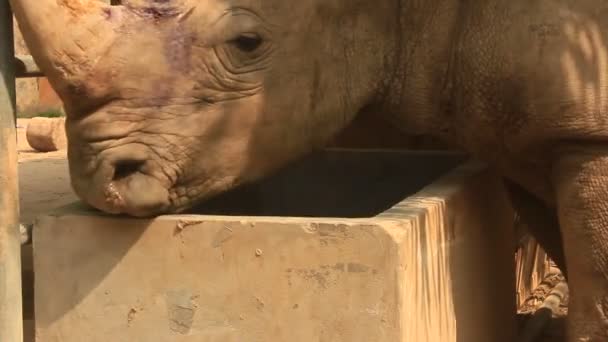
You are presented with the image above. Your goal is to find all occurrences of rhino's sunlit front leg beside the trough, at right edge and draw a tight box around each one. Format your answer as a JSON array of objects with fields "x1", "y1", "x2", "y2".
[{"x1": 552, "y1": 145, "x2": 608, "y2": 342}]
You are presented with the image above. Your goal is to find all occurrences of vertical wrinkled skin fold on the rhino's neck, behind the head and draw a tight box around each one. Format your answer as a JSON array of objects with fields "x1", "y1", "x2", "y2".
[{"x1": 380, "y1": 0, "x2": 462, "y2": 138}]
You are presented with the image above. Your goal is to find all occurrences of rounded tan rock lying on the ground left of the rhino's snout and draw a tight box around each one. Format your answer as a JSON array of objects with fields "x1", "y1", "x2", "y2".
[{"x1": 26, "y1": 117, "x2": 67, "y2": 152}]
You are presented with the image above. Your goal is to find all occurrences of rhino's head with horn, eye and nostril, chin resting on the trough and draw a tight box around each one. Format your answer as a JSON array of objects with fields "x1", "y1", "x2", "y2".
[{"x1": 11, "y1": 0, "x2": 398, "y2": 217}]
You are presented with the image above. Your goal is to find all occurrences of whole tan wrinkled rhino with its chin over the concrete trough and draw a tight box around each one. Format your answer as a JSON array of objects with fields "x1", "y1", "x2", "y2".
[{"x1": 11, "y1": 0, "x2": 608, "y2": 342}]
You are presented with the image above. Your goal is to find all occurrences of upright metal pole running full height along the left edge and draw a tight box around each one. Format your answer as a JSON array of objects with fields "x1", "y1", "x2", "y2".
[{"x1": 0, "y1": 0, "x2": 23, "y2": 342}]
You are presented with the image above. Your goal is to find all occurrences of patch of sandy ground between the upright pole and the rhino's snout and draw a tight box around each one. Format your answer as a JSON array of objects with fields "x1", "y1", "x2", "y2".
[{"x1": 17, "y1": 119, "x2": 77, "y2": 224}]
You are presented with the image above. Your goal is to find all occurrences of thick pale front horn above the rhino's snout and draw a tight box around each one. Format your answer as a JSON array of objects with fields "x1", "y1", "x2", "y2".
[{"x1": 10, "y1": 0, "x2": 121, "y2": 98}]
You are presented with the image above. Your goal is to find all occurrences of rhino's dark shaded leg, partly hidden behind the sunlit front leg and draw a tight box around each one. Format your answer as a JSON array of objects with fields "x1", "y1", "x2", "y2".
[{"x1": 505, "y1": 180, "x2": 568, "y2": 278}]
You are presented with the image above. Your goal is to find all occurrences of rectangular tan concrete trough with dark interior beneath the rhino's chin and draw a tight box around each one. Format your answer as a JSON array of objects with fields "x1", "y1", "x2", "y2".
[{"x1": 33, "y1": 150, "x2": 515, "y2": 342}]
